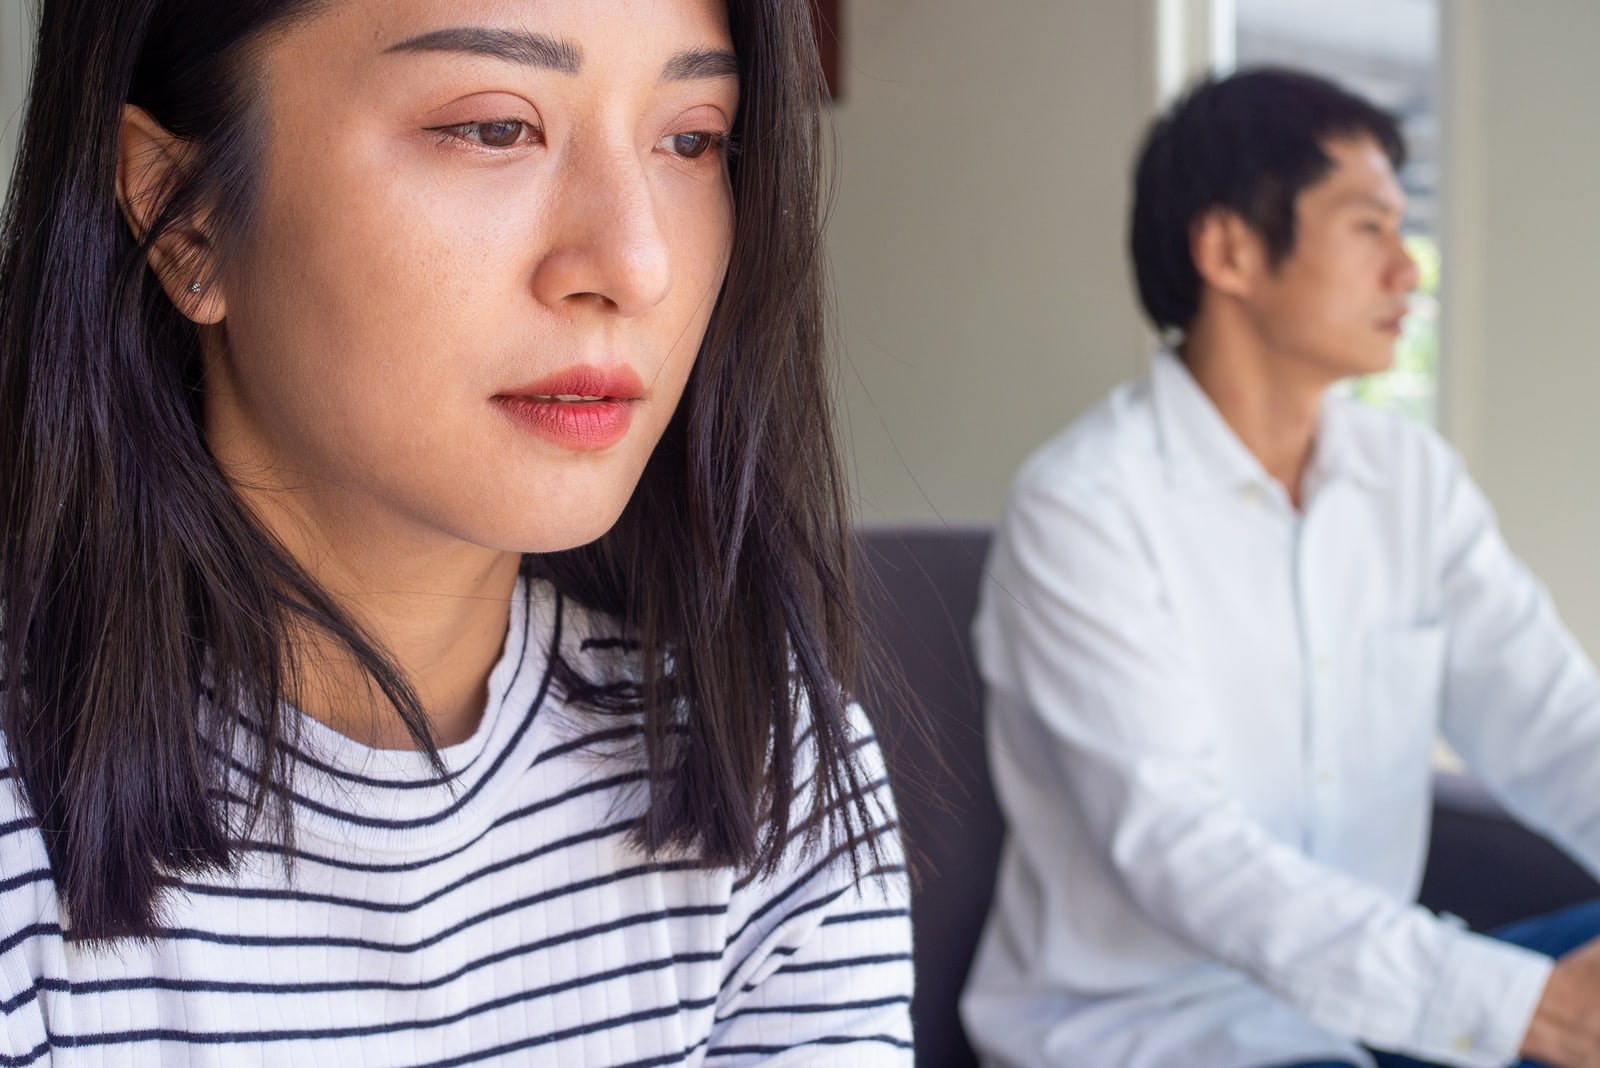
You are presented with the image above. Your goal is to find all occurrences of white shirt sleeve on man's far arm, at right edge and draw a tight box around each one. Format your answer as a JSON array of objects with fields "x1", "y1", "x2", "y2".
[{"x1": 1437, "y1": 446, "x2": 1600, "y2": 876}]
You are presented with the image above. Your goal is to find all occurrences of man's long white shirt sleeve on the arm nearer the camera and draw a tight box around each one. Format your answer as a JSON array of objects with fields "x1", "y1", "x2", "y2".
[{"x1": 979, "y1": 478, "x2": 1550, "y2": 1066}]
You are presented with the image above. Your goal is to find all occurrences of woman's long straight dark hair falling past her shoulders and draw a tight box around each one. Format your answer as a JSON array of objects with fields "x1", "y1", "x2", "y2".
[{"x1": 0, "y1": 0, "x2": 874, "y2": 938}]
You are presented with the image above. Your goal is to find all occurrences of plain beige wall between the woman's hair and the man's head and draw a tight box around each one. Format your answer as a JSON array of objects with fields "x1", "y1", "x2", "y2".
[{"x1": 829, "y1": 0, "x2": 1155, "y2": 521}]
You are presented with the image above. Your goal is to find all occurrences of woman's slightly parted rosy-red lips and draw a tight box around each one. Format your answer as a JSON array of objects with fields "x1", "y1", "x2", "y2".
[{"x1": 494, "y1": 366, "x2": 645, "y2": 452}]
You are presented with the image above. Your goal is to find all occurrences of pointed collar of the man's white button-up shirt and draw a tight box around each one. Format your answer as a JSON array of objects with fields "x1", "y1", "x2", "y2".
[{"x1": 1150, "y1": 350, "x2": 1384, "y2": 488}]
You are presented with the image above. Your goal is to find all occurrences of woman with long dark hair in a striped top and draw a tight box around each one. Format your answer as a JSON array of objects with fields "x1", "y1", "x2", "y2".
[{"x1": 0, "y1": 0, "x2": 910, "y2": 1066}]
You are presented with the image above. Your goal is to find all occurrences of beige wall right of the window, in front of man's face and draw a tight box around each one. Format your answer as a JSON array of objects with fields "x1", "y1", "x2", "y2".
[{"x1": 1443, "y1": 0, "x2": 1600, "y2": 656}]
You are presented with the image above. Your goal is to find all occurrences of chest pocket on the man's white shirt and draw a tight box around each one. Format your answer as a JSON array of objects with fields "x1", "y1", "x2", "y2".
[{"x1": 1349, "y1": 624, "x2": 1448, "y2": 791}]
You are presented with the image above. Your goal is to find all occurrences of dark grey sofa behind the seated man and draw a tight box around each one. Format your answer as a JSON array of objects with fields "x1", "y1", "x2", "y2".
[{"x1": 858, "y1": 526, "x2": 1600, "y2": 1068}]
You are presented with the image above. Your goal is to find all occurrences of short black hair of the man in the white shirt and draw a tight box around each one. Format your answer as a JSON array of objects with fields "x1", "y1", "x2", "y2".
[{"x1": 1128, "y1": 67, "x2": 1405, "y2": 331}]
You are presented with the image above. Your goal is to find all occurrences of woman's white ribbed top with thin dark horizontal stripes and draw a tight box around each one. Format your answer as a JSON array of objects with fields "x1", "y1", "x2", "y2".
[{"x1": 0, "y1": 584, "x2": 912, "y2": 1068}]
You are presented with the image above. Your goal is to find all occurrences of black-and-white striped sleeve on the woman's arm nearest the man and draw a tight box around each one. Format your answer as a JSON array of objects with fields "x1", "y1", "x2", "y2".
[{"x1": 706, "y1": 703, "x2": 912, "y2": 1068}]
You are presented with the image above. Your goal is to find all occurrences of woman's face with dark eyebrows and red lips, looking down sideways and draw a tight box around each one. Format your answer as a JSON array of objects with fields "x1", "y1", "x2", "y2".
[{"x1": 205, "y1": 0, "x2": 739, "y2": 552}]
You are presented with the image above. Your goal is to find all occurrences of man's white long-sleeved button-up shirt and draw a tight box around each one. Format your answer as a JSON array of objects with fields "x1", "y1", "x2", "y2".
[{"x1": 962, "y1": 353, "x2": 1600, "y2": 1068}]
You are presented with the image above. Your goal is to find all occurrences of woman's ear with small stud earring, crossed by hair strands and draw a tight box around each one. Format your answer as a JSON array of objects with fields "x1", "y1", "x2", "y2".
[{"x1": 117, "y1": 104, "x2": 227, "y2": 325}]
